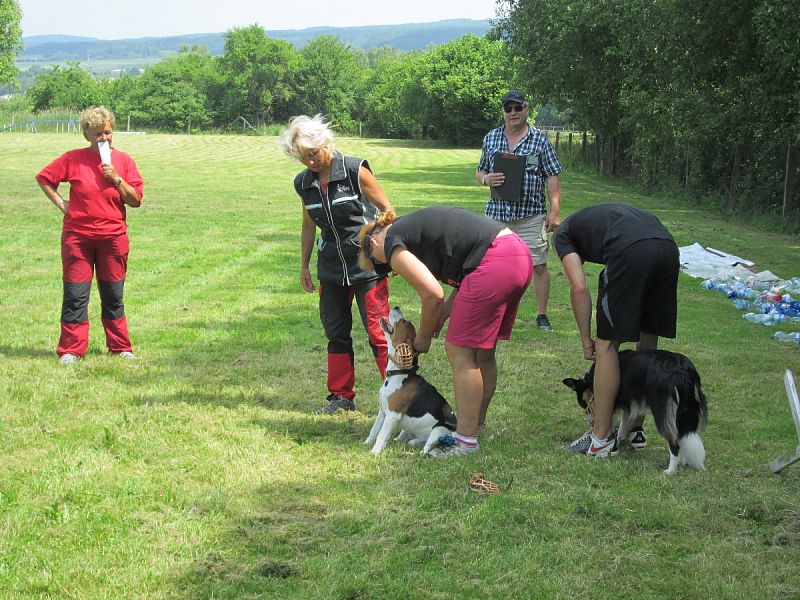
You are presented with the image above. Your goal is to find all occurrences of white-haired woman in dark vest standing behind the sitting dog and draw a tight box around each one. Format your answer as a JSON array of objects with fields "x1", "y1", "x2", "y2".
[{"x1": 278, "y1": 115, "x2": 392, "y2": 414}]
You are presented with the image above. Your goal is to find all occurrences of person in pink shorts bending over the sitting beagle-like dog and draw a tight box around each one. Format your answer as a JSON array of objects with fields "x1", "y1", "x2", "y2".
[{"x1": 359, "y1": 206, "x2": 533, "y2": 457}]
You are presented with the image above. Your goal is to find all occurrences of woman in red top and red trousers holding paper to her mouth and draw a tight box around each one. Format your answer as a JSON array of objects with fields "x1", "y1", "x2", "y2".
[{"x1": 36, "y1": 107, "x2": 144, "y2": 364}]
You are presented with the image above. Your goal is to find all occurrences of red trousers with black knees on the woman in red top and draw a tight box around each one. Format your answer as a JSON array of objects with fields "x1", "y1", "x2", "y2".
[{"x1": 58, "y1": 232, "x2": 133, "y2": 356}]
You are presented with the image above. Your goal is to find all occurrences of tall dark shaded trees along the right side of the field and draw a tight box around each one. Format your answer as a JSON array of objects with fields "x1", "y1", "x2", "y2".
[{"x1": 498, "y1": 0, "x2": 800, "y2": 218}]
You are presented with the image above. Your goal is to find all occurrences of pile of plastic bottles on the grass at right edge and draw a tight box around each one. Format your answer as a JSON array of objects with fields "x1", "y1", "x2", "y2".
[{"x1": 700, "y1": 277, "x2": 800, "y2": 345}]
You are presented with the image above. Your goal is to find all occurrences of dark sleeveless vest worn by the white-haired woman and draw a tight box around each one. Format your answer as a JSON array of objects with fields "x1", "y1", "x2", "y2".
[{"x1": 294, "y1": 152, "x2": 389, "y2": 285}]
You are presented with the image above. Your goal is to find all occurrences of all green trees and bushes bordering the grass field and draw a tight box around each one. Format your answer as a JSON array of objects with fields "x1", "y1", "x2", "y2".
[{"x1": 0, "y1": 0, "x2": 800, "y2": 220}]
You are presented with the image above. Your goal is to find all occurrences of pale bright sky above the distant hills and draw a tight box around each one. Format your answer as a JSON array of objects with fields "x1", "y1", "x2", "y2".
[{"x1": 18, "y1": 0, "x2": 496, "y2": 40}]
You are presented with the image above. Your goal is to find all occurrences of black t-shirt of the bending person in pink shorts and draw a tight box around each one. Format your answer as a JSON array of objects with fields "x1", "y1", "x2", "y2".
[{"x1": 383, "y1": 206, "x2": 504, "y2": 287}]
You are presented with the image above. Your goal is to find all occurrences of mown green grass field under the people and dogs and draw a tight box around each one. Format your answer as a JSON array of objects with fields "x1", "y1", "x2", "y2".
[{"x1": 0, "y1": 134, "x2": 800, "y2": 600}]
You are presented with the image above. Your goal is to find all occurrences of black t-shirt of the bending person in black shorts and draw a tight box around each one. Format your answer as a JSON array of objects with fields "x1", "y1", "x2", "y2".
[{"x1": 553, "y1": 203, "x2": 675, "y2": 265}]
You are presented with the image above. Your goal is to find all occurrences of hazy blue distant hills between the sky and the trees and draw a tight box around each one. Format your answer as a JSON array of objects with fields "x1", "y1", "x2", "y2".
[{"x1": 17, "y1": 19, "x2": 491, "y2": 64}]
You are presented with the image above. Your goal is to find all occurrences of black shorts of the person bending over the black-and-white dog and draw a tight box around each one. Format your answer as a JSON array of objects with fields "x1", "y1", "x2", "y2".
[{"x1": 597, "y1": 239, "x2": 680, "y2": 342}]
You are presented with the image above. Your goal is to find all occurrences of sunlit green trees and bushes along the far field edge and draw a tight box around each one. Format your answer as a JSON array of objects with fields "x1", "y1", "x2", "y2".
[{"x1": 17, "y1": 25, "x2": 510, "y2": 144}]
